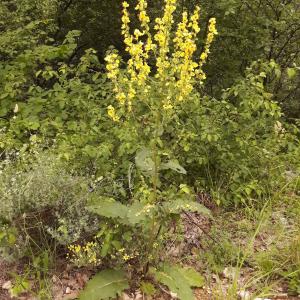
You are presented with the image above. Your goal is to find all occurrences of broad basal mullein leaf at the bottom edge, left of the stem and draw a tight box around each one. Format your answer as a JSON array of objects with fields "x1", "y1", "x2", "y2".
[{"x1": 79, "y1": 269, "x2": 129, "y2": 300}]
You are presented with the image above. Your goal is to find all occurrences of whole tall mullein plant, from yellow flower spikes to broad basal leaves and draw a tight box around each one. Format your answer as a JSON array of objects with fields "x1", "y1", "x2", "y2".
[{"x1": 78, "y1": 0, "x2": 217, "y2": 300}]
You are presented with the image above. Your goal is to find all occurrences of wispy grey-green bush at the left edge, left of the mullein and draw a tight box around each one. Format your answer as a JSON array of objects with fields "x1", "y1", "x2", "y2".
[{"x1": 0, "y1": 152, "x2": 98, "y2": 250}]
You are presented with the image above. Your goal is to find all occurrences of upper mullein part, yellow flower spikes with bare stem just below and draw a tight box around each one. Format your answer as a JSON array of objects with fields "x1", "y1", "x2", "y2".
[{"x1": 105, "y1": 0, "x2": 218, "y2": 199}]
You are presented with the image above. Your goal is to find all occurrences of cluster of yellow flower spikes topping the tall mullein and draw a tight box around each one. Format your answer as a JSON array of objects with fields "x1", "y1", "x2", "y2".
[{"x1": 106, "y1": 0, "x2": 217, "y2": 118}]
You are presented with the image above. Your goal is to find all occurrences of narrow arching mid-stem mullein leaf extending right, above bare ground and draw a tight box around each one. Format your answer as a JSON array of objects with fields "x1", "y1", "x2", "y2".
[{"x1": 164, "y1": 198, "x2": 210, "y2": 215}]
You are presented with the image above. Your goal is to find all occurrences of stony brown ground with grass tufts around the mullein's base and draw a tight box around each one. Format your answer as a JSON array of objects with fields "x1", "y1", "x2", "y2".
[{"x1": 0, "y1": 200, "x2": 300, "y2": 300}]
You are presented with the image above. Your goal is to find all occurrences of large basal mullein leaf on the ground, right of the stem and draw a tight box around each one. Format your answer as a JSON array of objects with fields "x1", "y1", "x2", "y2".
[{"x1": 150, "y1": 264, "x2": 200, "y2": 300}]
